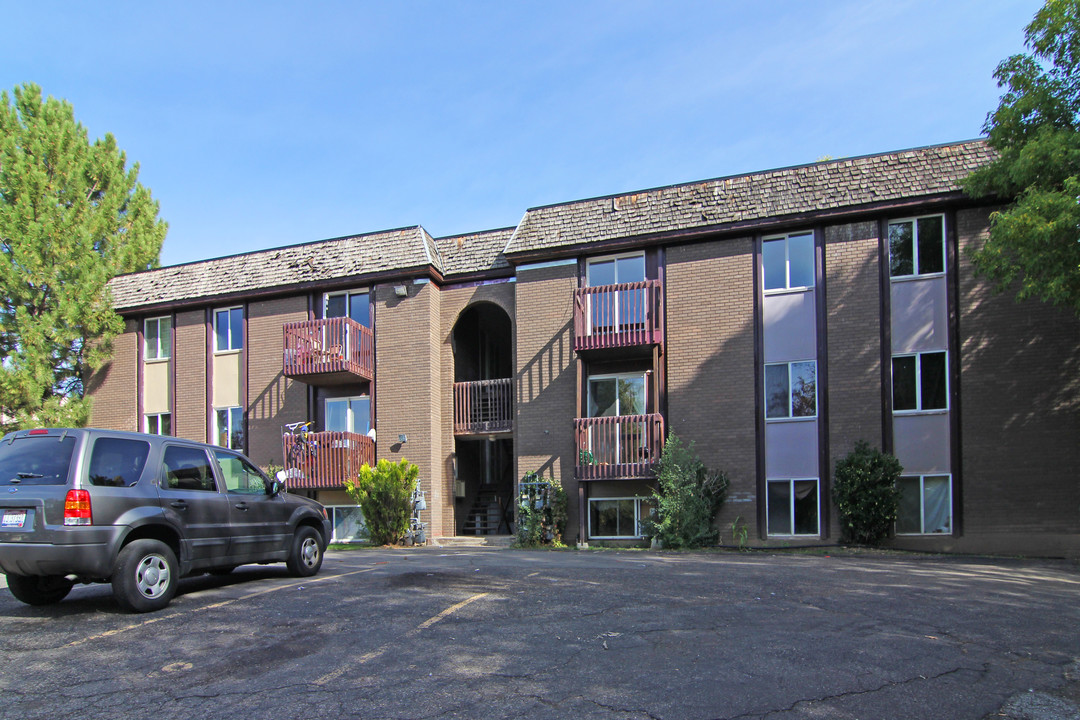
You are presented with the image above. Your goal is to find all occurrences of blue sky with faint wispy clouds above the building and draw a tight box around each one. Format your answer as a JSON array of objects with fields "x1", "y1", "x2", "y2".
[{"x1": 0, "y1": 0, "x2": 1042, "y2": 264}]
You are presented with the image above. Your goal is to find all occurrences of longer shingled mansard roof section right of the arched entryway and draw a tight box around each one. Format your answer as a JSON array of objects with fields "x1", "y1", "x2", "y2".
[{"x1": 503, "y1": 140, "x2": 995, "y2": 258}]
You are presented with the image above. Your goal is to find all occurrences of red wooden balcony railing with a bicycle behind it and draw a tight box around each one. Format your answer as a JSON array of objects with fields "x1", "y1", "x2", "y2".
[{"x1": 282, "y1": 432, "x2": 375, "y2": 490}]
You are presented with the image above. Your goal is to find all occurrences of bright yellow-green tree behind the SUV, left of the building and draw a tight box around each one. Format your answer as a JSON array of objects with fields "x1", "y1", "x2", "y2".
[{"x1": 0, "y1": 84, "x2": 167, "y2": 430}]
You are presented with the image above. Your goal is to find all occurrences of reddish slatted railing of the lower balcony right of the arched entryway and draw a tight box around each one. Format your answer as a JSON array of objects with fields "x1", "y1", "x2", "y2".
[{"x1": 573, "y1": 412, "x2": 664, "y2": 480}]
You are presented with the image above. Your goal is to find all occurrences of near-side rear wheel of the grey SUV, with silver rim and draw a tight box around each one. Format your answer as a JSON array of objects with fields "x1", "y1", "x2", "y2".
[{"x1": 112, "y1": 539, "x2": 180, "y2": 612}]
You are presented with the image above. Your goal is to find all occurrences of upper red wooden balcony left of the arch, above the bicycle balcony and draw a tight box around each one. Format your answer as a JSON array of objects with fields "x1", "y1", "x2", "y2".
[{"x1": 282, "y1": 317, "x2": 375, "y2": 385}]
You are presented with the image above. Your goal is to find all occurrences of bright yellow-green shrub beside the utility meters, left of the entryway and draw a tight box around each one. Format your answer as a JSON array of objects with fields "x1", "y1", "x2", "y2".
[{"x1": 345, "y1": 458, "x2": 420, "y2": 545}]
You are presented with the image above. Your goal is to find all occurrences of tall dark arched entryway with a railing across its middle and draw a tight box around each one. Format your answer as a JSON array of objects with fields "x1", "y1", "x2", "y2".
[{"x1": 450, "y1": 302, "x2": 514, "y2": 535}]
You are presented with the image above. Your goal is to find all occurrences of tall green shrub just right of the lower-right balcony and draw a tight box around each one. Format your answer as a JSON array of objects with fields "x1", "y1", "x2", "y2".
[{"x1": 644, "y1": 434, "x2": 728, "y2": 548}]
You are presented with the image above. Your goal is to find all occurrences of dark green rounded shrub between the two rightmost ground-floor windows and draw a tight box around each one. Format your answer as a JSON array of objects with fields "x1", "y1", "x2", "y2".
[{"x1": 833, "y1": 440, "x2": 903, "y2": 545}]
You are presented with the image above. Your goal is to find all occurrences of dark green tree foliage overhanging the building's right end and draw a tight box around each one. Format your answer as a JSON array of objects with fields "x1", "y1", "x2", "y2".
[{"x1": 966, "y1": 0, "x2": 1080, "y2": 314}]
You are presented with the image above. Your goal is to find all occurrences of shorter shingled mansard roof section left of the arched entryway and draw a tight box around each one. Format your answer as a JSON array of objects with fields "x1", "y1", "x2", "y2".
[{"x1": 109, "y1": 226, "x2": 442, "y2": 310}]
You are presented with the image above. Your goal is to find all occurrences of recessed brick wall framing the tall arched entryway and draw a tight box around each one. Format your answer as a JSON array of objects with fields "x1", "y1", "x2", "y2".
[{"x1": 436, "y1": 283, "x2": 514, "y2": 535}]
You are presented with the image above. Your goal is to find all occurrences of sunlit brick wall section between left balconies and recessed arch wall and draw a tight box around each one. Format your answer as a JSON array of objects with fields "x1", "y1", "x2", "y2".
[{"x1": 374, "y1": 283, "x2": 454, "y2": 538}]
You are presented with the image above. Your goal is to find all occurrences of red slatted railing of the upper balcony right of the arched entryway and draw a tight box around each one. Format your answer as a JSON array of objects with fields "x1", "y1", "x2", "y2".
[{"x1": 573, "y1": 280, "x2": 664, "y2": 351}]
